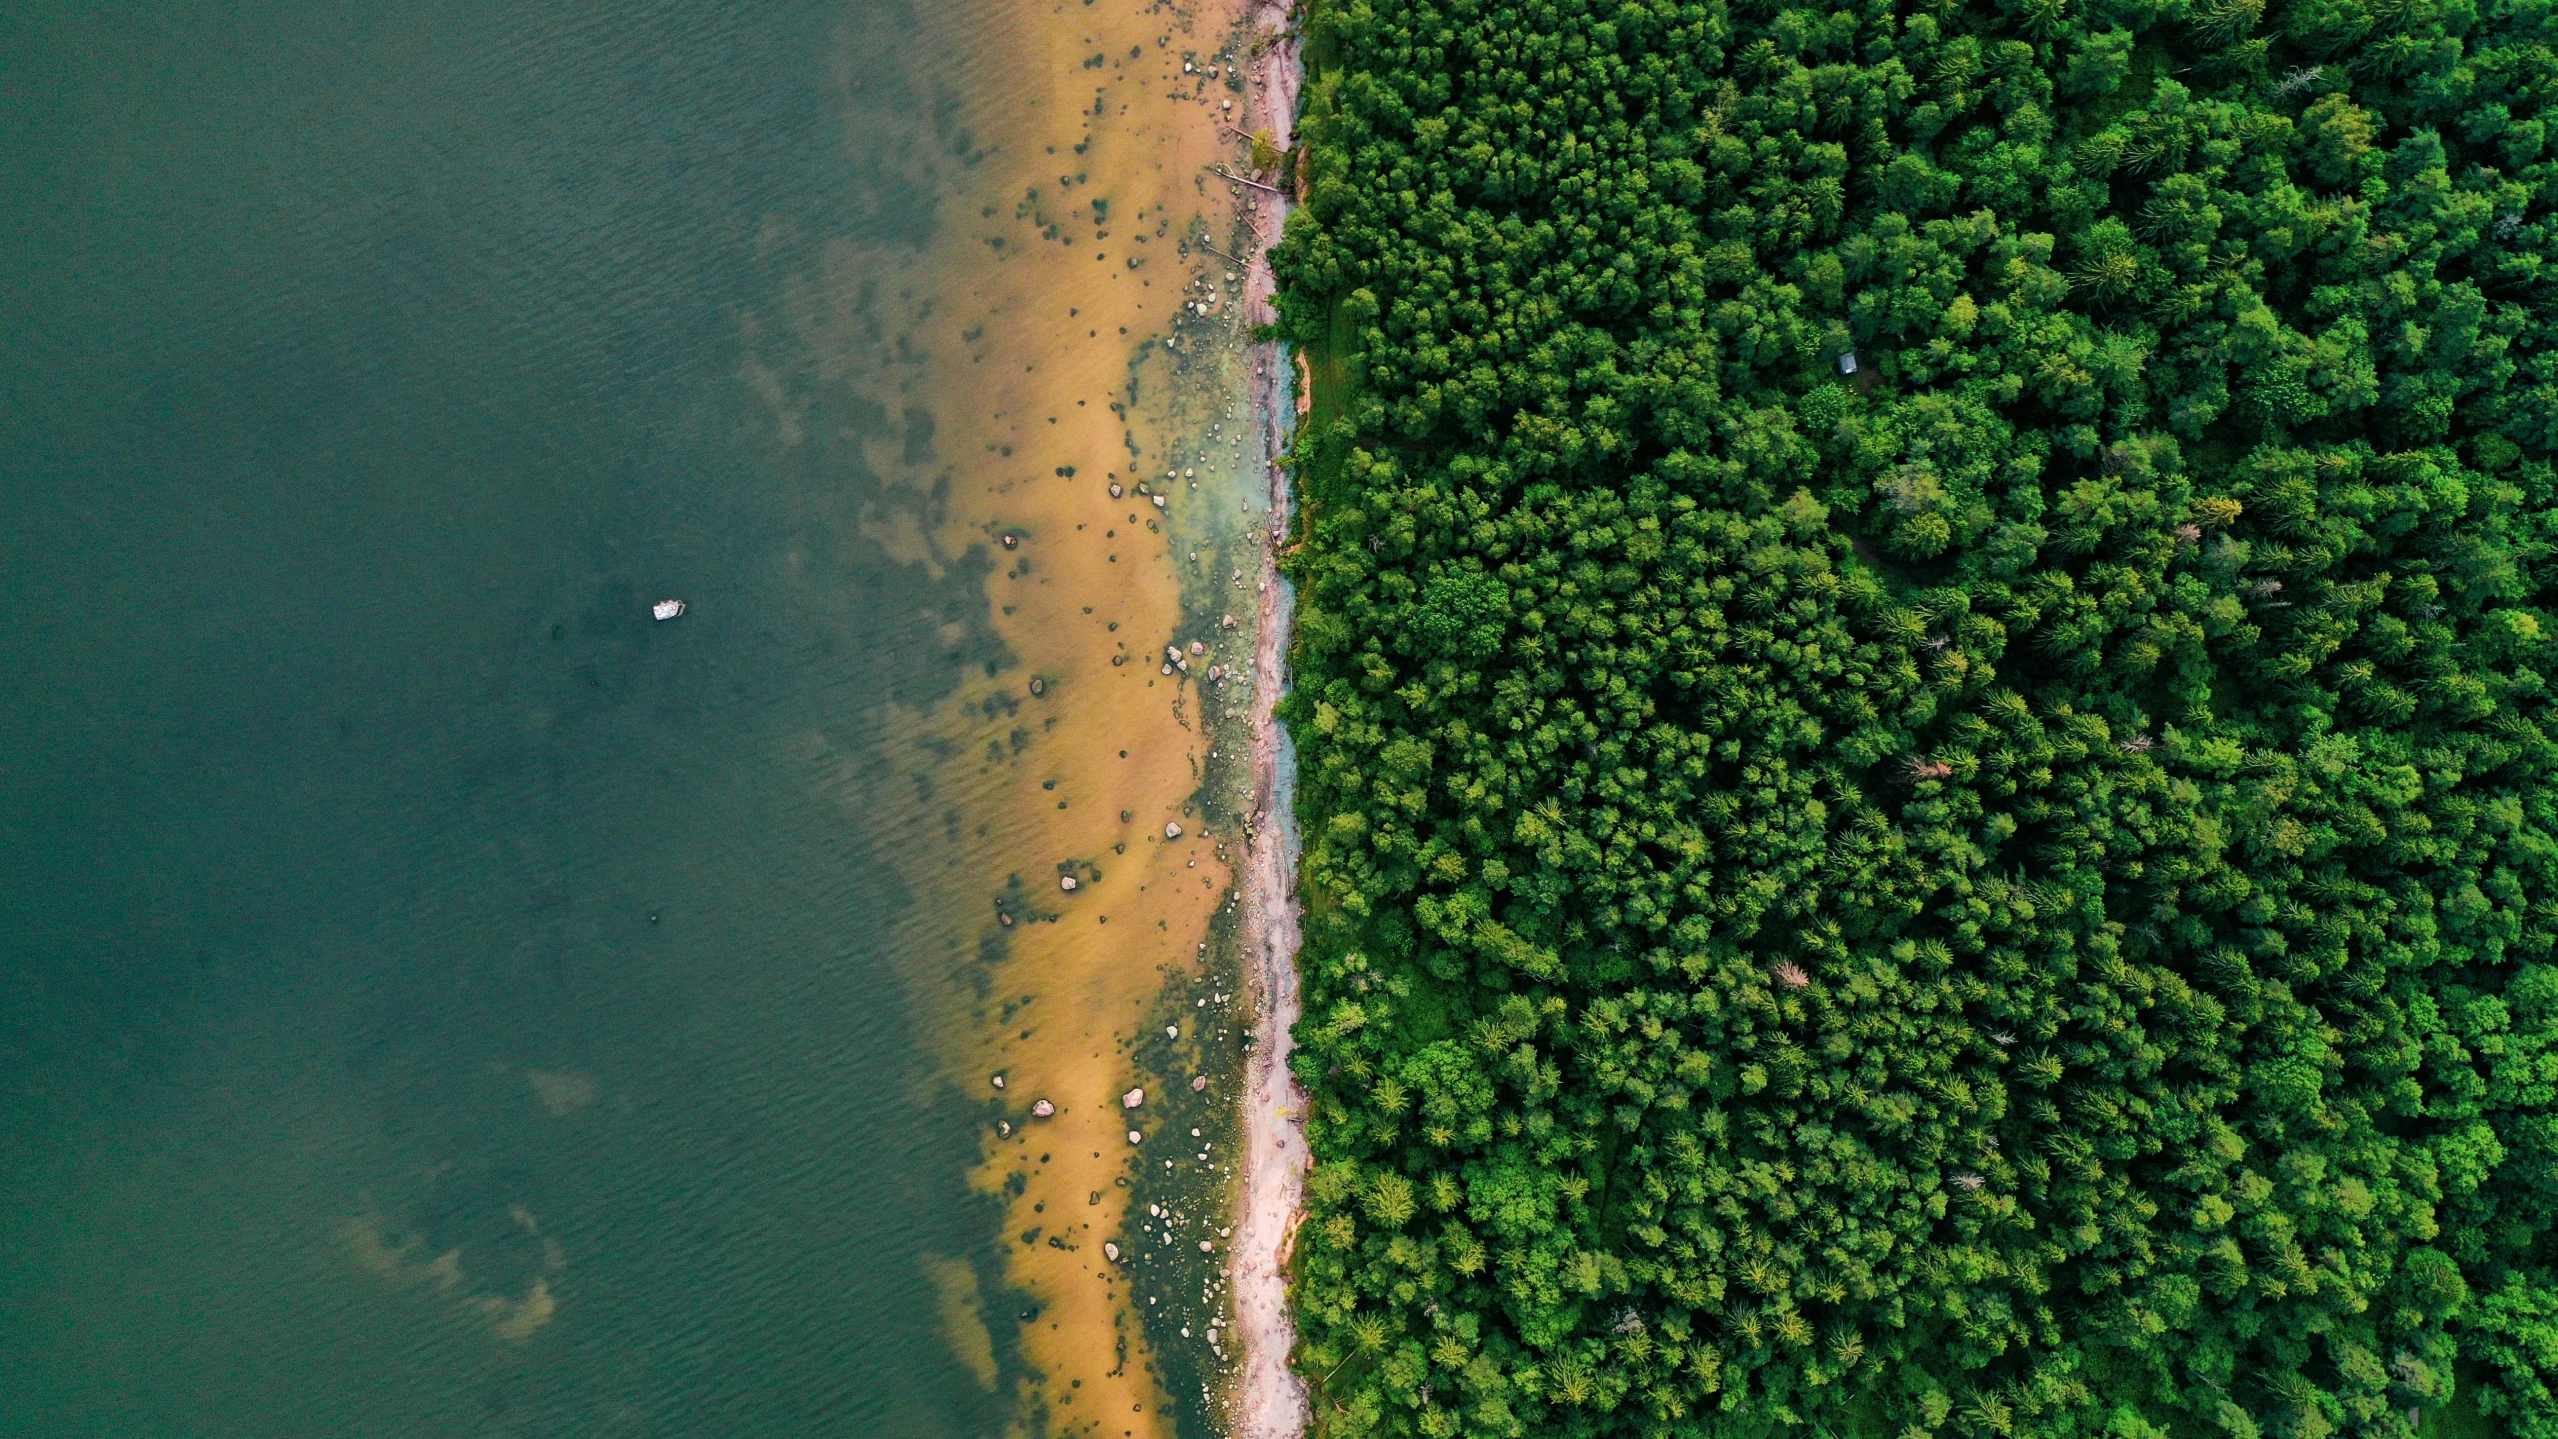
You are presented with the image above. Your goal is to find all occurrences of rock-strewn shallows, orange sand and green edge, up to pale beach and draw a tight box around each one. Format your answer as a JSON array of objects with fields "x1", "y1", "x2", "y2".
[{"x1": 813, "y1": 0, "x2": 1284, "y2": 1439}]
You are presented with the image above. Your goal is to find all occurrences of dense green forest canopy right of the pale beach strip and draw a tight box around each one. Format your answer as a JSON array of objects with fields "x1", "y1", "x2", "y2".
[{"x1": 1274, "y1": 0, "x2": 2558, "y2": 1439}]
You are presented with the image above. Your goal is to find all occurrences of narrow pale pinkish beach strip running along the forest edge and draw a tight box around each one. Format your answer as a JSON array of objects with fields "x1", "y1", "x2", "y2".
[{"x1": 1230, "y1": 0, "x2": 1310, "y2": 1439}]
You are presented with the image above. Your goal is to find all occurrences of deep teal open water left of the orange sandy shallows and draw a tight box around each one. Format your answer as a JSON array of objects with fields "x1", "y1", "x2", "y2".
[{"x1": 0, "y1": 0, "x2": 1003, "y2": 1439}]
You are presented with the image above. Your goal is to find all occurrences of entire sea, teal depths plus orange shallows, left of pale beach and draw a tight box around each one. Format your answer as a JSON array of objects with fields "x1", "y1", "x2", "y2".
[{"x1": 0, "y1": 0, "x2": 1259, "y2": 1436}]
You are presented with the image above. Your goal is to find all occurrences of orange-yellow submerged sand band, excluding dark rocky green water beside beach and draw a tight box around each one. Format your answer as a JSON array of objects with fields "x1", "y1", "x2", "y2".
[{"x1": 742, "y1": 0, "x2": 1253, "y2": 1439}]
